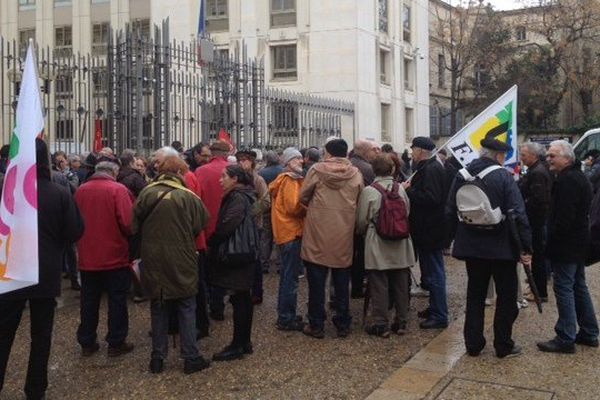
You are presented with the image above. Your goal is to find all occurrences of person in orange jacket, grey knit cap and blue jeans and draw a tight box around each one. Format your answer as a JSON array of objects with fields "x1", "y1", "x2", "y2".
[{"x1": 269, "y1": 147, "x2": 305, "y2": 331}]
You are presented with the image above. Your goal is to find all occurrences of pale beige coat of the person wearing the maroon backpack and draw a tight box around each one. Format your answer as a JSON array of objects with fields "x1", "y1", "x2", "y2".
[{"x1": 356, "y1": 176, "x2": 416, "y2": 271}]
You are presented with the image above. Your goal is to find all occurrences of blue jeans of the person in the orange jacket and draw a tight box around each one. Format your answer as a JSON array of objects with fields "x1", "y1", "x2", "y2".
[{"x1": 277, "y1": 239, "x2": 302, "y2": 324}]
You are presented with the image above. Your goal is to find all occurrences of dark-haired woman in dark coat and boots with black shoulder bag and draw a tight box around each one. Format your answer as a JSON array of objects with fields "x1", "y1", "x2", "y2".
[{"x1": 208, "y1": 165, "x2": 258, "y2": 361}]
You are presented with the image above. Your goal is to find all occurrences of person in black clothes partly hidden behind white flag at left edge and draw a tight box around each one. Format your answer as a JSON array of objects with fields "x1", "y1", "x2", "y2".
[{"x1": 0, "y1": 139, "x2": 84, "y2": 399}]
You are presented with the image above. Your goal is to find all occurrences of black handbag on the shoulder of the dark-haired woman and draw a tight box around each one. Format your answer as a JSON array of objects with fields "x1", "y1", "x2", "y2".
[{"x1": 217, "y1": 195, "x2": 259, "y2": 267}]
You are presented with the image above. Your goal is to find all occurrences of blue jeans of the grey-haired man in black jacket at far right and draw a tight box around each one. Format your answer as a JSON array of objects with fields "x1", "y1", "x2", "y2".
[{"x1": 550, "y1": 260, "x2": 598, "y2": 345}]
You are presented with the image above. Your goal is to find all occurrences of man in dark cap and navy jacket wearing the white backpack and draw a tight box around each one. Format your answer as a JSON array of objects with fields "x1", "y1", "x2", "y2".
[{"x1": 446, "y1": 136, "x2": 531, "y2": 358}]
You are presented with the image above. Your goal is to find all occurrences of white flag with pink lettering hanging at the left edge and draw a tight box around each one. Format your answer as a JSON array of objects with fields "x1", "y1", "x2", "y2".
[{"x1": 0, "y1": 43, "x2": 44, "y2": 293}]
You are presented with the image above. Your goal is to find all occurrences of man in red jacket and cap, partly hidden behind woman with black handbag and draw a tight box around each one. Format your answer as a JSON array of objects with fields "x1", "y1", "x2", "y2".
[{"x1": 194, "y1": 141, "x2": 230, "y2": 321}]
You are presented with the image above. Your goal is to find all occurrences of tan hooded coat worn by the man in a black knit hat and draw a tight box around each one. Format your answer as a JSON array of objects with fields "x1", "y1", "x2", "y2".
[{"x1": 300, "y1": 157, "x2": 363, "y2": 268}]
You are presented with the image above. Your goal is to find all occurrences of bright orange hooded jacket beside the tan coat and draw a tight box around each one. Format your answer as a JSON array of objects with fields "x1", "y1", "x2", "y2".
[{"x1": 269, "y1": 172, "x2": 306, "y2": 244}]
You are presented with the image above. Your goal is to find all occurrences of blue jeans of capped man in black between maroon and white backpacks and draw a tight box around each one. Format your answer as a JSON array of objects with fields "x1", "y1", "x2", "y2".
[{"x1": 417, "y1": 249, "x2": 448, "y2": 323}]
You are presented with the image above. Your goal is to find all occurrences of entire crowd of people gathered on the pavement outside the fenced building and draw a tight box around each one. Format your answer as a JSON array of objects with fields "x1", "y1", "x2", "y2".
[{"x1": 0, "y1": 137, "x2": 600, "y2": 399}]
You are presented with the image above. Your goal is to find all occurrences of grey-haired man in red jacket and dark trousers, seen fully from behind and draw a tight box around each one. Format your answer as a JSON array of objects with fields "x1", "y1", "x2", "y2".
[{"x1": 75, "y1": 161, "x2": 133, "y2": 357}]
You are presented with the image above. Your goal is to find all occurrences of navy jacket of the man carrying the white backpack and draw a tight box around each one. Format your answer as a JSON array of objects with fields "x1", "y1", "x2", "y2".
[{"x1": 446, "y1": 158, "x2": 531, "y2": 261}]
